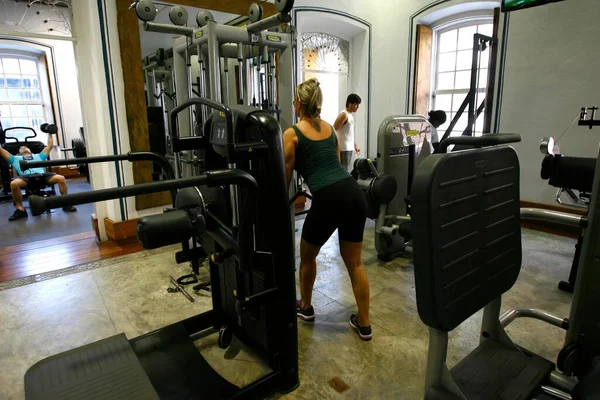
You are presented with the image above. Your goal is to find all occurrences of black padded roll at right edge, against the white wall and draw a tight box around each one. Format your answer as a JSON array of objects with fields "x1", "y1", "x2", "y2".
[{"x1": 541, "y1": 155, "x2": 596, "y2": 193}]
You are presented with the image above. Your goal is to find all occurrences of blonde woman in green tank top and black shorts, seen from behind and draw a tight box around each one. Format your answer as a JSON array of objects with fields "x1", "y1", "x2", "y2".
[{"x1": 283, "y1": 79, "x2": 373, "y2": 340}]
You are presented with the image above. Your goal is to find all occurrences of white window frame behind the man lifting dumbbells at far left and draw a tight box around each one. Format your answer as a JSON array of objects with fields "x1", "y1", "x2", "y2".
[{"x1": 0, "y1": 48, "x2": 54, "y2": 144}]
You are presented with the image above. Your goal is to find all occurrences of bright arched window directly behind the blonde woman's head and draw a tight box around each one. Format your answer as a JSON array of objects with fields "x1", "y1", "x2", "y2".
[{"x1": 300, "y1": 33, "x2": 350, "y2": 124}]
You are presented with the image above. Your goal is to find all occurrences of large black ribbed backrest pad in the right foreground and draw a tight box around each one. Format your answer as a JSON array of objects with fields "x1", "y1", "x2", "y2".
[{"x1": 411, "y1": 147, "x2": 521, "y2": 331}]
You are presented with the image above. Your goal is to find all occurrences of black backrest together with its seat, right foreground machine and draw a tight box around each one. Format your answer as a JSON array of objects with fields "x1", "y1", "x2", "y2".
[{"x1": 411, "y1": 147, "x2": 554, "y2": 400}]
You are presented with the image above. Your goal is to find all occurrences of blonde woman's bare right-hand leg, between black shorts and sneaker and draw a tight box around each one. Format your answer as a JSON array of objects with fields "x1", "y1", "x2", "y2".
[{"x1": 340, "y1": 240, "x2": 371, "y2": 326}]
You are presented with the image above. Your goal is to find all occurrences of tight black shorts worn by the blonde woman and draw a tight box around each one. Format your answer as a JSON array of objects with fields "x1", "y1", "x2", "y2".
[{"x1": 302, "y1": 177, "x2": 367, "y2": 247}]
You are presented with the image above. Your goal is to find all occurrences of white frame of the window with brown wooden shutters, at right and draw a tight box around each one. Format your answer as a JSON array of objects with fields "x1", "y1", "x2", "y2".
[{"x1": 429, "y1": 14, "x2": 494, "y2": 136}]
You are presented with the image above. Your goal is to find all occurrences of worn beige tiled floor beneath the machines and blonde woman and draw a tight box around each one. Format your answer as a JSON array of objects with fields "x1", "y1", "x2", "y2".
[{"x1": 0, "y1": 226, "x2": 574, "y2": 399}]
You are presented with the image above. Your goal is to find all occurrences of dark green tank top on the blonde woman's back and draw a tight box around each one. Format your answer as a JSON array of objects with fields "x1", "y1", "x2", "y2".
[{"x1": 292, "y1": 125, "x2": 350, "y2": 194}]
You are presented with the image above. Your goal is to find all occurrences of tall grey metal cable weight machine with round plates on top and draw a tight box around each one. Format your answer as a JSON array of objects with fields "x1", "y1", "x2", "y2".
[{"x1": 132, "y1": 0, "x2": 293, "y2": 177}]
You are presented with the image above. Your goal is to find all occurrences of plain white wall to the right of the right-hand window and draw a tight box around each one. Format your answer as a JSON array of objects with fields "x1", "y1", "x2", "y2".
[{"x1": 499, "y1": 0, "x2": 600, "y2": 204}]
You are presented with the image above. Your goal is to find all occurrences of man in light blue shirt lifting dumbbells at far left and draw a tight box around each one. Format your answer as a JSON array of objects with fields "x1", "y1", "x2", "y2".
[{"x1": 0, "y1": 134, "x2": 77, "y2": 221}]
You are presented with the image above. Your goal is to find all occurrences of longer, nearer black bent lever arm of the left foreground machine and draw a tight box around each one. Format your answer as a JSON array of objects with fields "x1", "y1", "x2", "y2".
[{"x1": 29, "y1": 169, "x2": 258, "y2": 216}]
